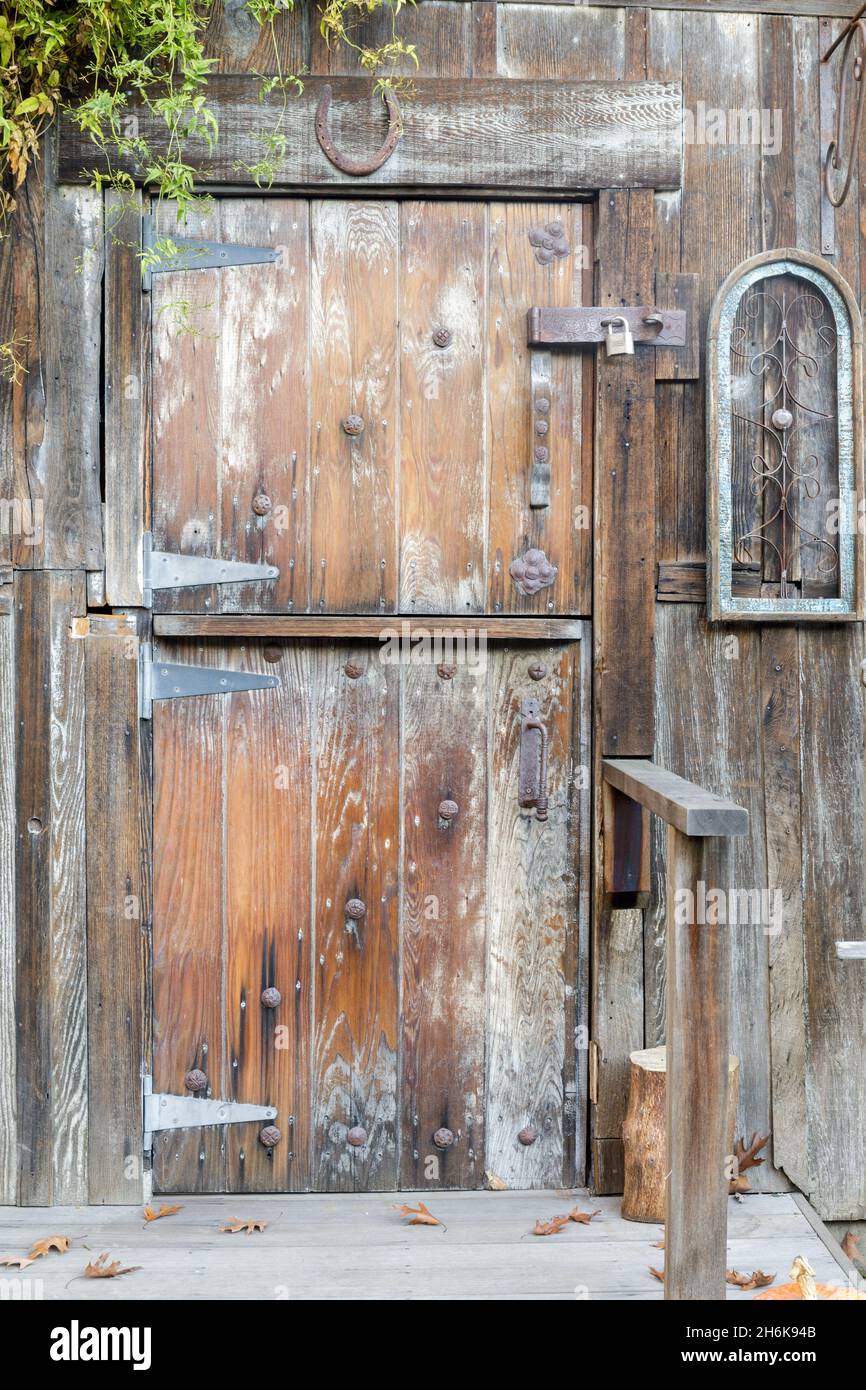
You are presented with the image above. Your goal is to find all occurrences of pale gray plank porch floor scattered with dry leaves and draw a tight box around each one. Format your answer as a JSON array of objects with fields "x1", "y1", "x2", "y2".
[{"x1": 0, "y1": 1193, "x2": 845, "y2": 1301}]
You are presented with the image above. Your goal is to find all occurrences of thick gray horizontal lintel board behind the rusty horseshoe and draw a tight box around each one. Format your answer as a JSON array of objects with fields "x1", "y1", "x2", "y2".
[{"x1": 58, "y1": 74, "x2": 683, "y2": 195}]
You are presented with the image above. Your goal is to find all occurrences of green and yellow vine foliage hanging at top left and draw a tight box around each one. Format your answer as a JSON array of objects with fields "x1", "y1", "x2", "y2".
[{"x1": 0, "y1": 0, "x2": 417, "y2": 235}]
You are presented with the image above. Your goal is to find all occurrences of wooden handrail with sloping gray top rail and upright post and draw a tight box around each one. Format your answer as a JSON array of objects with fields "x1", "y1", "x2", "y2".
[{"x1": 602, "y1": 758, "x2": 749, "y2": 1300}]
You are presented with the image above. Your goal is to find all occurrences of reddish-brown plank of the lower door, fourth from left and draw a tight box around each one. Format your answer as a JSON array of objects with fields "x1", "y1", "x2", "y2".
[{"x1": 400, "y1": 663, "x2": 489, "y2": 1190}]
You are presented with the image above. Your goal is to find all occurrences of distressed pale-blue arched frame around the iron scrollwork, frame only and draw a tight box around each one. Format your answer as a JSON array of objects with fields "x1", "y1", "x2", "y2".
[{"x1": 706, "y1": 247, "x2": 865, "y2": 623}]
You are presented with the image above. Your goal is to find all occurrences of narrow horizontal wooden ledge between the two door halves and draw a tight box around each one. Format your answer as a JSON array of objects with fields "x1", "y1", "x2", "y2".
[{"x1": 153, "y1": 613, "x2": 584, "y2": 644}]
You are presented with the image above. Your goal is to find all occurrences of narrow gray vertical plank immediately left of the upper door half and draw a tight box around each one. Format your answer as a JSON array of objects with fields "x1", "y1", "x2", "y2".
[{"x1": 103, "y1": 190, "x2": 150, "y2": 607}]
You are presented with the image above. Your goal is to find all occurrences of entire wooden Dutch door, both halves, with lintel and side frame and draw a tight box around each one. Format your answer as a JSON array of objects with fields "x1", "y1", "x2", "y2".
[{"x1": 61, "y1": 78, "x2": 683, "y2": 1194}]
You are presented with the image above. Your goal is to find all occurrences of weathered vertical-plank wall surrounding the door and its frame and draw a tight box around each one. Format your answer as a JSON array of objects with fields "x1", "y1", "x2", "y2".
[{"x1": 0, "y1": 0, "x2": 866, "y2": 1218}]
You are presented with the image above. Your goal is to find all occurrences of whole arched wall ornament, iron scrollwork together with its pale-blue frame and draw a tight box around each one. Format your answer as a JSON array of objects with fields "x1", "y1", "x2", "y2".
[{"x1": 708, "y1": 250, "x2": 863, "y2": 621}]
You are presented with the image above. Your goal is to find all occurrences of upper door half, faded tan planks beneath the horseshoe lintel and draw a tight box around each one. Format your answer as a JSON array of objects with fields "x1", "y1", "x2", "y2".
[{"x1": 152, "y1": 197, "x2": 592, "y2": 616}]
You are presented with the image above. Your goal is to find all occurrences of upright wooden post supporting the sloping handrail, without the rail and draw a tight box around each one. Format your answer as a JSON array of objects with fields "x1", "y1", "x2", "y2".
[{"x1": 664, "y1": 824, "x2": 731, "y2": 1300}]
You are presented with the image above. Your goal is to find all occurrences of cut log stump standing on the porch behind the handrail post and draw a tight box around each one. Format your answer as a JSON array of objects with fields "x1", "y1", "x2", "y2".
[{"x1": 623, "y1": 1047, "x2": 740, "y2": 1225}]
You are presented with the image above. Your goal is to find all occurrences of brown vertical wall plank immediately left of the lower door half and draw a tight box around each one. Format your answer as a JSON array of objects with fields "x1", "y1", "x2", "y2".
[{"x1": 85, "y1": 619, "x2": 146, "y2": 1202}]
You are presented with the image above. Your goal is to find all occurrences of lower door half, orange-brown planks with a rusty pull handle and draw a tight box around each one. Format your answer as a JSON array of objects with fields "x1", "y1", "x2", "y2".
[{"x1": 153, "y1": 636, "x2": 588, "y2": 1194}]
